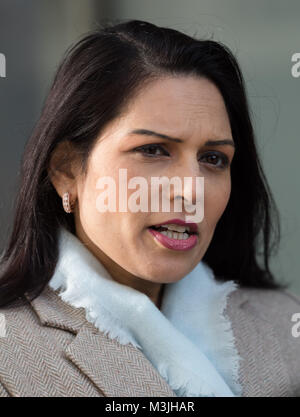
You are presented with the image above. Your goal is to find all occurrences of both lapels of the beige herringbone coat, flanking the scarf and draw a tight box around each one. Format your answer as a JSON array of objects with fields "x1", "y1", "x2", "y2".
[{"x1": 24, "y1": 285, "x2": 290, "y2": 397}]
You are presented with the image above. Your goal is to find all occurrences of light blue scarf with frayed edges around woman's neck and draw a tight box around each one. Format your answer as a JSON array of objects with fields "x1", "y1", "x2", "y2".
[{"x1": 49, "y1": 227, "x2": 241, "y2": 397}]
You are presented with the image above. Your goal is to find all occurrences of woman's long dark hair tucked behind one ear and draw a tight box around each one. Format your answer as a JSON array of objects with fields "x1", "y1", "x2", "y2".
[{"x1": 0, "y1": 20, "x2": 280, "y2": 306}]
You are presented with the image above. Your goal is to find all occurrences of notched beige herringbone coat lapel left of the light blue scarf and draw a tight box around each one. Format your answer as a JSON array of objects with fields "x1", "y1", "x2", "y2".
[{"x1": 27, "y1": 286, "x2": 176, "y2": 397}]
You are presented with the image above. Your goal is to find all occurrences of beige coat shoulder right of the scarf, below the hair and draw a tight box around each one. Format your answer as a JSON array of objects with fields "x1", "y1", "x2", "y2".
[{"x1": 226, "y1": 288, "x2": 300, "y2": 396}]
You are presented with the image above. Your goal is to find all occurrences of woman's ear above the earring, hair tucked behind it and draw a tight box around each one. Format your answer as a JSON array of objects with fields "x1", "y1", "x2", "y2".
[{"x1": 47, "y1": 141, "x2": 79, "y2": 199}]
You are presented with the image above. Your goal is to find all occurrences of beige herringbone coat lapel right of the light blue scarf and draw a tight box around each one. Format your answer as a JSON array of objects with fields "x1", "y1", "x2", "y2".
[{"x1": 226, "y1": 289, "x2": 291, "y2": 397}]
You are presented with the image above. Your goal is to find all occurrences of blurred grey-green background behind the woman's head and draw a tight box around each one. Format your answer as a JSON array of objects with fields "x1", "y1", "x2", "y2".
[{"x1": 0, "y1": 0, "x2": 300, "y2": 294}]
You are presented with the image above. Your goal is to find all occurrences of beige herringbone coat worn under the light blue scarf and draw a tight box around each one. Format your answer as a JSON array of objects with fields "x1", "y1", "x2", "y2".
[{"x1": 0, "y1": 286, "x2": 300, "y2": 397}]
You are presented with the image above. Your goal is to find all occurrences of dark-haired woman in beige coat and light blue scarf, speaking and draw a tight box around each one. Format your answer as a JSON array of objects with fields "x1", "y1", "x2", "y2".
[{"x1": 0, "y1": 20, "x2": 300, "y2": 396}]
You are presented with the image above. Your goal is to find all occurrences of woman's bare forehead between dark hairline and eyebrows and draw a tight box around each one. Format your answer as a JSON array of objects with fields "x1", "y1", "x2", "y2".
[{"x1": 117, "y1": 76, "x2": 230, "y2": 136}]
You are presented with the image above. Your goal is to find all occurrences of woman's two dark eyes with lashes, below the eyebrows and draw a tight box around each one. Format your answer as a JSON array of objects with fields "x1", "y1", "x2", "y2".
[{"x1": 132, "y1": 143, "x2": 229, "y2": 169}]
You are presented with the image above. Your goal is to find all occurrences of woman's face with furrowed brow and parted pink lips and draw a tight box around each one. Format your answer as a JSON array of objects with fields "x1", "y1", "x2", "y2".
[{"x1": 75, "y1": 76, "x2": 234, "y2": 283}]
